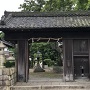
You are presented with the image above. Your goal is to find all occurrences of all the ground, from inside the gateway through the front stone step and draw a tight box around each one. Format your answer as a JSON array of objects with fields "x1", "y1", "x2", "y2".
[{"x1": 5, "y1": 72, "x2": 90, "y2": 90}]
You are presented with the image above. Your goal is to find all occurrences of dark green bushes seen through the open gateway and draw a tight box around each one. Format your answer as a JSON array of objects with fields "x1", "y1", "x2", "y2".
[{"x1": 30, "y1": 42, "x2": 62, "y2": 66}]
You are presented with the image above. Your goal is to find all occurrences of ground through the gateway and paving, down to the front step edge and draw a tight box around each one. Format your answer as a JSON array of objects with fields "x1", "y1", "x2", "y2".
[{"x1": 16, "y1": 73, "x2": 90, "y2": 86}]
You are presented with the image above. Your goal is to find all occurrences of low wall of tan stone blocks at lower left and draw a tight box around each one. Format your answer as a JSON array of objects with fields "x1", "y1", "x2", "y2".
[{"x1": 0, "y1": 68, "x2": 16, "y2": 86}]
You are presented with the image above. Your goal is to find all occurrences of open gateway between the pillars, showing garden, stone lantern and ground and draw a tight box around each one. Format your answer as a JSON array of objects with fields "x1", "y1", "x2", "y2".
[{"x1": 29, "y1": 38, "x2": 63, "y2": 81}]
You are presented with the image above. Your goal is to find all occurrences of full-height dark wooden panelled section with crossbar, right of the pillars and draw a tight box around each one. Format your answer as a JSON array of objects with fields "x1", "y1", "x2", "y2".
[{"x1": 73, "y1": 39, "x2": 89, "y2": 78}]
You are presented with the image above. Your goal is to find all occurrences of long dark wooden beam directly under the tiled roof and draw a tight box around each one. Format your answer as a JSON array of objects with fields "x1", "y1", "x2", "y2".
[{"x1": 4, "y1": 28, "x2": 90, "y2": 40}]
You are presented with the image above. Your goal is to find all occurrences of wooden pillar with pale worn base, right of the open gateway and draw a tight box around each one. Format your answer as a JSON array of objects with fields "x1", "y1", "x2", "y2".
[{"x1": 63, "y1": 39, "x2": 73, "y2": 81}]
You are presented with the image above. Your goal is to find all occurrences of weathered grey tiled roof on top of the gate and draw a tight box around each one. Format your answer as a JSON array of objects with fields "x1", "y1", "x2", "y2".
[{"x1": 0, "y1": 11, "x2": 90, "y2": 29}]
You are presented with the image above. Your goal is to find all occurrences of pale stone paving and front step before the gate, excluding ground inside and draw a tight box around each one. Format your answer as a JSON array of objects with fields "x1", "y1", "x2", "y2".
[{"x1": 12, "y1": 78, "x2": 90, "y2": 90}]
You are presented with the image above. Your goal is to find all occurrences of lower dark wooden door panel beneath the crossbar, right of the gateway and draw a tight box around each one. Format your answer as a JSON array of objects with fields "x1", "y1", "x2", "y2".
[{"x1": 74, "y1": 57, "x2": 89, "y2": 78}]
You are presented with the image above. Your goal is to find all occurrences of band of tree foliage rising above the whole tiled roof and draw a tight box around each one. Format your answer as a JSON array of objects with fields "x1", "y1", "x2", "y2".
[{"x1": 20, "y1": 0, "x2": 90, "y2": 12}]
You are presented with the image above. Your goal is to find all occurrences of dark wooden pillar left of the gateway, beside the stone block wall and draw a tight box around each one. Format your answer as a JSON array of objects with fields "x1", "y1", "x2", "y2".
[{"x1": 17, "y1": 40, "x2": 29, "y2": 82}]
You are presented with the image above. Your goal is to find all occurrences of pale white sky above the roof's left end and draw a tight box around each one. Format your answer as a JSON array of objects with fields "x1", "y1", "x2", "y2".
[{"x1": 0, "y1": 0, "x2": 24, "y2": 19}]
